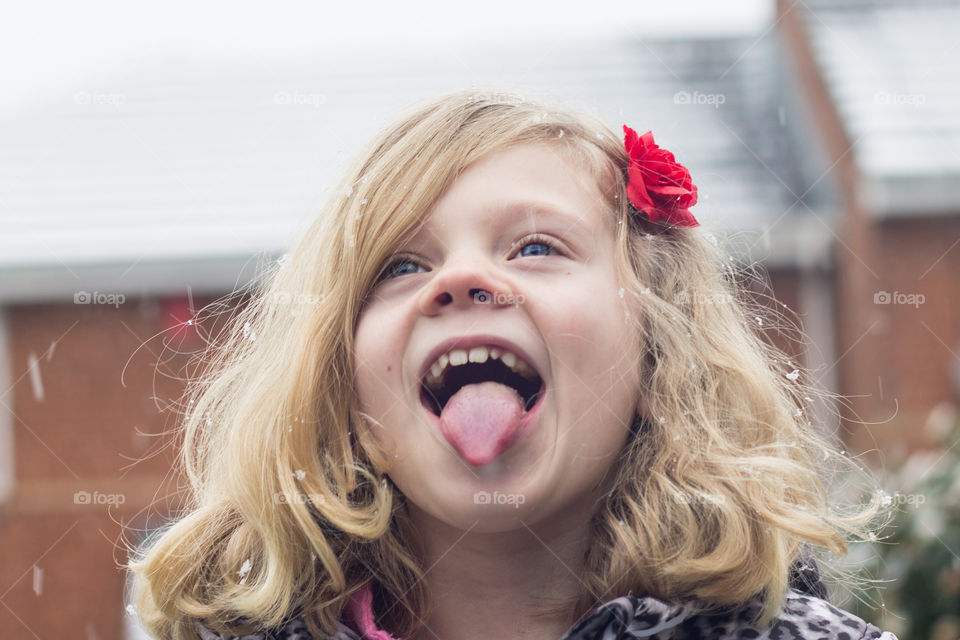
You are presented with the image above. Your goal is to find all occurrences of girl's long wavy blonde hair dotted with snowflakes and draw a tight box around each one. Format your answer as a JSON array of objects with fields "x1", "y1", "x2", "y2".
[{"x1": 128, "y1": 87, "x2": 878, "y2": 640}]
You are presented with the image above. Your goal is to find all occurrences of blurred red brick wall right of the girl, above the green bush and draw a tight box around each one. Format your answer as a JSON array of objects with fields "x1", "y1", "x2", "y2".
[{"x1": 841, "y1": 218, "x2": 960, "y2": 452}]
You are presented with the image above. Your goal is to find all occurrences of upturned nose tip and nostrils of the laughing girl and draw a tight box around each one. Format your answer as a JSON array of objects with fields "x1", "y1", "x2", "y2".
[{"x1": 419, "y1": 261, "x2": 514, "y2": 316}]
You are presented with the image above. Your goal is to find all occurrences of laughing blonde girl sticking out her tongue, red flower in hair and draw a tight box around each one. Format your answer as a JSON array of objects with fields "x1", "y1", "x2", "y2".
[{"x1": 130, "y1": 93, "x2": 894, "y2": 640}]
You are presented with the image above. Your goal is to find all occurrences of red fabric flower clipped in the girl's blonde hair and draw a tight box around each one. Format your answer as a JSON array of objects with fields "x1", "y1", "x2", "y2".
[{"x1": 623, "y1": 125, "x2": 700, "y2": 227}]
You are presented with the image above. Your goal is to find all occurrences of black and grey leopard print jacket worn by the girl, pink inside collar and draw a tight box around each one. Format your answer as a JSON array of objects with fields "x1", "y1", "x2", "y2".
[{"x1": 197, "y1": 565, "x2": 897, "y2": 640}]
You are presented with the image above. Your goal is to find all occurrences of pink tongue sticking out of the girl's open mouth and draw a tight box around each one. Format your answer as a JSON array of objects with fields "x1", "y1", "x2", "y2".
[{"x1": 440, "y1": 382, "x2": 524, "y2": 467}]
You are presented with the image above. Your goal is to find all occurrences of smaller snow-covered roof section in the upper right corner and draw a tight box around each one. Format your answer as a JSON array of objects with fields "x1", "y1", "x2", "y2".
[{"x1": 804, "y1": 0, "x2": 960, "y2": 215}]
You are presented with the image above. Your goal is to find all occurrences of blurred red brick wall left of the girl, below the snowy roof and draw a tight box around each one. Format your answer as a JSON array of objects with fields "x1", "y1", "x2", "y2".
[{"x1": 0, "y1": 299, "x2": 221, "y2": 640}]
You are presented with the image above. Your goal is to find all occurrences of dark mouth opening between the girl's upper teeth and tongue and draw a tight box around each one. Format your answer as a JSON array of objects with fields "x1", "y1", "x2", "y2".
[{"x1": 420, "y1": 358, "x2": 545, "y2": 417}]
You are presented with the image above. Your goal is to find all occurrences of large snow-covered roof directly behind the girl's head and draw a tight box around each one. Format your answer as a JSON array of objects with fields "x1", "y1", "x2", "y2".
[{"x1": 0, "y1": 36, "x2": 833, "y2": 302}]
